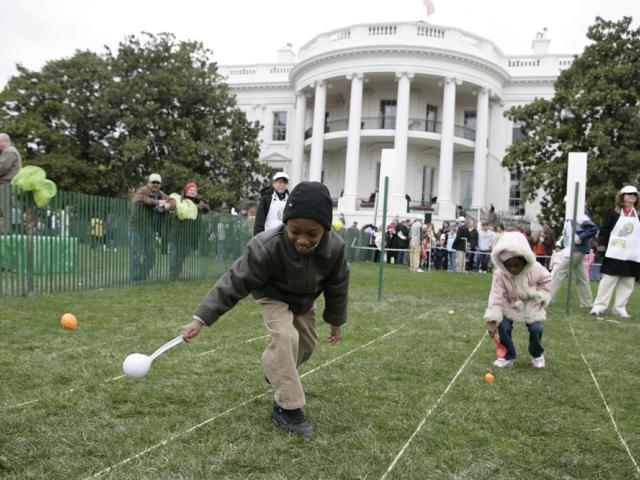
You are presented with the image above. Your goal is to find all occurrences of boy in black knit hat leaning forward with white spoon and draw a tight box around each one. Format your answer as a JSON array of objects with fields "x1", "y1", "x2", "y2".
[{"x1": 180, "y1": 182, "x2": 349, "y2": 436}]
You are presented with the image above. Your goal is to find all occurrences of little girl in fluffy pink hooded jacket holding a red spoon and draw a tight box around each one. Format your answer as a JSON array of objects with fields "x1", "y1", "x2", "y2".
[{"x1": 484, "y1": 232, "x2": 551, "y2": 368}]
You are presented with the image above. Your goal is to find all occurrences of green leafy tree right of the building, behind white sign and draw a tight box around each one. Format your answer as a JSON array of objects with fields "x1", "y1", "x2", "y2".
[{"x1": 503, "y1": 17, "x2": 640, "y2": 228}]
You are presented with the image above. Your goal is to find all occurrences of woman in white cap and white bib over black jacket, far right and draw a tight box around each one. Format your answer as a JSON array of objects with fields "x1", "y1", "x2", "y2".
[{"x1": 591, "y1": 185, "x2": 640, "y2": 318}]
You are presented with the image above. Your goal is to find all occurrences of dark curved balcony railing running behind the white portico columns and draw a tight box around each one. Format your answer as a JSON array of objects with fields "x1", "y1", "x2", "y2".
[{"x1": 304, "y1": 116, "x2": 476, "y2": 141}]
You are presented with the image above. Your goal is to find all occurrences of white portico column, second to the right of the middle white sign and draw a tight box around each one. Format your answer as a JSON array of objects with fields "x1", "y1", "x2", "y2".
[{"x1": 438, "y1": 77, "x2": 456, "y2": 219}]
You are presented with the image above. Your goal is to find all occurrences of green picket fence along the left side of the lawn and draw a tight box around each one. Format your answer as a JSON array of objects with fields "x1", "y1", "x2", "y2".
[{"x1": 0, "y1": 183, "x2": 253, "y2": 297}]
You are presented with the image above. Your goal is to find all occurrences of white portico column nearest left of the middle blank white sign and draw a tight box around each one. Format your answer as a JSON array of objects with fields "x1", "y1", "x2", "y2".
[{"x1": 338, "y1": 73, "x2": 363, "y2": 212}]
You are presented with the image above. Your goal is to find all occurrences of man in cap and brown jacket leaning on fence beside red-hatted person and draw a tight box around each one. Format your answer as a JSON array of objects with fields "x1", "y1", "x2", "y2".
[{"x1": 129, "y1": 173, "x2": 176, "y2": 283}]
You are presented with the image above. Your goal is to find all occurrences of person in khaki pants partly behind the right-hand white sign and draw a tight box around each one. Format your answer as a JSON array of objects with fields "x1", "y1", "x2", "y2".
[{"x1": 551, "y1": 210, "x2": 598, "y2": 308}]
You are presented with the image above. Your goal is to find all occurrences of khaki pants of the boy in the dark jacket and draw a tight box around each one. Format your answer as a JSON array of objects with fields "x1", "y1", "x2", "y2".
[{"x1": 257, "y1": 297, "x2": 318, "y2": 410}]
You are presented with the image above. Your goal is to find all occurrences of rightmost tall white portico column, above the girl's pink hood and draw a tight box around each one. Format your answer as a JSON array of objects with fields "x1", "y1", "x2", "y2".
[{"x1": 471, "y1": 88, "x2": 489, "y2": 209}]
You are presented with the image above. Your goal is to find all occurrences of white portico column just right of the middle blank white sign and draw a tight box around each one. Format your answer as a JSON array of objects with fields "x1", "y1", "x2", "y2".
[{"x1": 391, "y1": 72, "x2": 413, "y2": 212}]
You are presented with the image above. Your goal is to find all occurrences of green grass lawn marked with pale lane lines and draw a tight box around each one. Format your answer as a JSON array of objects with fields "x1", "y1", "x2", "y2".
[{"x1": 0, "y1": 264, "x2": 640, "y2": 480}]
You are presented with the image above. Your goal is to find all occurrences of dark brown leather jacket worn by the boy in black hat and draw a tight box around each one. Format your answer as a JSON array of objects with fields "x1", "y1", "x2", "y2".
[{"x1": 194, "y1": 225, "x2": 349, "y2": 325}]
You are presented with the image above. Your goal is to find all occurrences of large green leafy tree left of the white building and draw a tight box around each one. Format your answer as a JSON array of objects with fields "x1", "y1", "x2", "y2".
[{"x1": 0, "y1": 33, "x2": 270, "y2": 206}]
